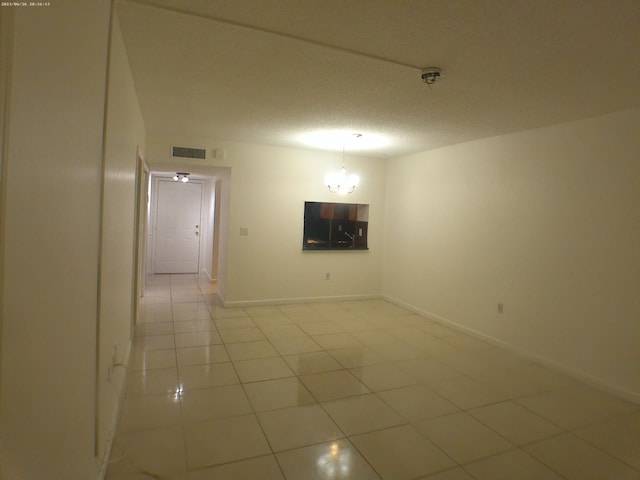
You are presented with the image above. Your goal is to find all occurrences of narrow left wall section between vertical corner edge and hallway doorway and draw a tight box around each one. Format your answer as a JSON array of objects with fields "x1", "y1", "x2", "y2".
[{"x1": 97, "y1": 11, "x2": 146, "y2": 472}]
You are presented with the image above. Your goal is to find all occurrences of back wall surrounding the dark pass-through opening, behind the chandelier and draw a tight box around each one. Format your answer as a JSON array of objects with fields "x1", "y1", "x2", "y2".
[{"x1": 147, "y1": 135, "x2": 385, "y2": 306}]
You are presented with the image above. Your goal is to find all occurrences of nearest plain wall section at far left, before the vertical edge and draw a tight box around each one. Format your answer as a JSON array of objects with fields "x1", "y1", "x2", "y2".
[{"x1": 0, "y1": 0, "x2": 110, "y2": 480}]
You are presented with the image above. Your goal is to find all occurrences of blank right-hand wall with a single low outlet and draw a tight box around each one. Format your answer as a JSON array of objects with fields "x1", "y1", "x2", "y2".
[{"x1": 383, "y1": 110, "x2": 640, "y2": 400}]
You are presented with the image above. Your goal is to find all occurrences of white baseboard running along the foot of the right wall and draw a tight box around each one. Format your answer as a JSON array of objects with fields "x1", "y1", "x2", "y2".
[{"x1": 381, "y1": 295, "x2": 640, "y2": 404}]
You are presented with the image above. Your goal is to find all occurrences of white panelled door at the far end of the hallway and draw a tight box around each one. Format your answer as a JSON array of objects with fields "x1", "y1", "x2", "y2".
[{"x1": 154, "y1": 180, "x2": 202, "y2": 273}]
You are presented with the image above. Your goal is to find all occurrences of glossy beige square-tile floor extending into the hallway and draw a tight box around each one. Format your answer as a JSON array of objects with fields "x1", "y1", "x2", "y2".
[{"x1": 107, "y1": 275, "x2": 640, "y2": 480}]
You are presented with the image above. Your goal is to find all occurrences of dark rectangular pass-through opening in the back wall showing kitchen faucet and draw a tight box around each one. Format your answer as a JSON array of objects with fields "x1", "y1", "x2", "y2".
[{"x1": 302, "y1": 202, "x2": 369, "y2": 250}]
